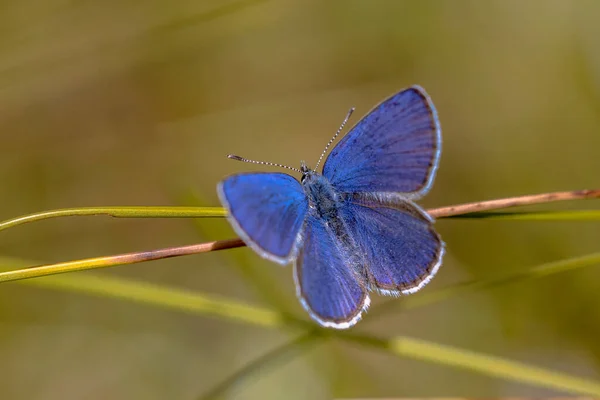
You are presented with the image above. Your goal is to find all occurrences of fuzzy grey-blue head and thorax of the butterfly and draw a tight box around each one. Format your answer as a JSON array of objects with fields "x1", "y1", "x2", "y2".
[{"x1": 302, "y1": 169, "x2": 341, "y2": 220}]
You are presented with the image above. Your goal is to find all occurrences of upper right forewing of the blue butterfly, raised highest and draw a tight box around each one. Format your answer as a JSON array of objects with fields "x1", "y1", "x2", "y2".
[{"x1": 323, "y1": 86, "x2": 441, "y2": 199}]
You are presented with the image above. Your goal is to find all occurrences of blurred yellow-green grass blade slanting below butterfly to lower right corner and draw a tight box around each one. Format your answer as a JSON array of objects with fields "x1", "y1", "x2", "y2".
[{"x1": 0, "y1": 258, "x2": 600, "y2": 396}]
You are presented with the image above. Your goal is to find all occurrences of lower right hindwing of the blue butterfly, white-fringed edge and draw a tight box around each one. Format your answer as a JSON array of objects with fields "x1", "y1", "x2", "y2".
[{"x1": 342, "y1": 198, "x2": 444, "y2": 295}]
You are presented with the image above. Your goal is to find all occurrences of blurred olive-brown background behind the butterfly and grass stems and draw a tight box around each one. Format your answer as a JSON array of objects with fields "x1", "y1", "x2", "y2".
[{"x1": 0, "y1": 0, "x2": 600, "y2": 399}]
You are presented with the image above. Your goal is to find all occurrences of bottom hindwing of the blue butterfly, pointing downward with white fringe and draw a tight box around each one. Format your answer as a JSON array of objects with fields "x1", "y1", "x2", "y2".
[{"x1": 295, "y1": 215, "x2": 369, "y2": 329}]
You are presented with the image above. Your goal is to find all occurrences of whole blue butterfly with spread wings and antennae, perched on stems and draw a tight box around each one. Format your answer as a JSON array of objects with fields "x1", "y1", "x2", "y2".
[{"x1": 218, "y1": 86, "x2": 444, "y2": 329}]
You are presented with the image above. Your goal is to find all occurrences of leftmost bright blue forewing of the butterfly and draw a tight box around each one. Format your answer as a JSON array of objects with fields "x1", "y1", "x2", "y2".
[{"x1": 217, "y1": 173, "x2": 308, "y2": 264}]
